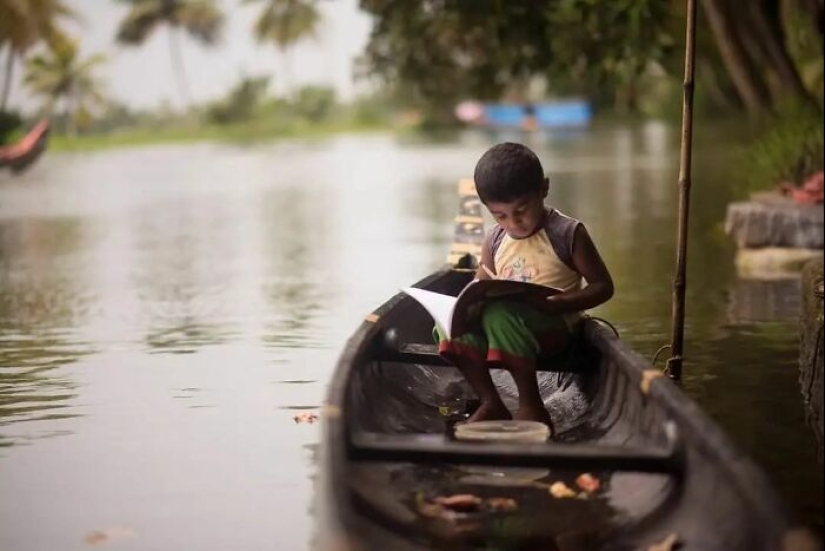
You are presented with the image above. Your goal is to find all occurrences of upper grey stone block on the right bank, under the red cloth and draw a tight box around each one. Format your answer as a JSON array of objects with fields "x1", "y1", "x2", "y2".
[{"x1": 725, "y1": 195, "x2": 825, "y2": 249}]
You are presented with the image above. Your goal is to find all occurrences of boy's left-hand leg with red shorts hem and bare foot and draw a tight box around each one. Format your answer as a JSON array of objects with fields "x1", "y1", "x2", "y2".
[{"x1": 433, "y1": 326, "x2": 512, "y2": 421}]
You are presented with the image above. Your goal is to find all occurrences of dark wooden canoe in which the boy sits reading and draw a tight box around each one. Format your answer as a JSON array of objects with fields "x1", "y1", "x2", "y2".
[{"x1": 319, "y1": 269, "x2": 789, "y2": 551}]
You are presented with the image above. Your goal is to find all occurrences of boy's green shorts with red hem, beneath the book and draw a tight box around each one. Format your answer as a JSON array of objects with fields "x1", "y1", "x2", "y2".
[{"x1": 433, "y1": 301, "x2": 573, "y2": 369}]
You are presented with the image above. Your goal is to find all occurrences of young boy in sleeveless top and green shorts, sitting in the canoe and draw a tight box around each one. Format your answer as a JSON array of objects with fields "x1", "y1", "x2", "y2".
[{"x1": 436, "y1": 143, "x2": 613, "y2": 428}]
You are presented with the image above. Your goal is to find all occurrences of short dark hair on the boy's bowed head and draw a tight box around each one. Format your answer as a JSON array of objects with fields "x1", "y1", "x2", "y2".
[{"x1": 475, "y1": 142, "x2": 545, "y2": 204}]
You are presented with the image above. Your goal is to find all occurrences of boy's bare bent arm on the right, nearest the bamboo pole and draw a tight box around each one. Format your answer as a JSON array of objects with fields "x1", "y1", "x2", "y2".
[{"x1": 542, "y1": 226, "x2": 615, "y2": 314}]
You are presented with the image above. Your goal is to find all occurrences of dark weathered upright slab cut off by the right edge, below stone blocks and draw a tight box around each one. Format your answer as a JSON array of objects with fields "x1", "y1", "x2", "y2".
[{"x1": 799, "y1": 260, "x2": 823, "y2": 461}]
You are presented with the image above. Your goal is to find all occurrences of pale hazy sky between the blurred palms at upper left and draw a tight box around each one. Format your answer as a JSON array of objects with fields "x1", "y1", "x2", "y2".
[{"x1": 12, "y1": 0, "x2": 370, "y2": 112}]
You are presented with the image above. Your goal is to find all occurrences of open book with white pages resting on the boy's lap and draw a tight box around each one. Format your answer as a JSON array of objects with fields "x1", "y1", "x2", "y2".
[{"x1": 402, "y1": 279, "x2": 562, "y2": 338}]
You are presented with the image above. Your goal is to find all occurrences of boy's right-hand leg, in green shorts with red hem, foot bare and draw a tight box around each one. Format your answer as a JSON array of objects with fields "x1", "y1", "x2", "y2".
[{"x1": 482, "y1": 302, "x2": 566, "y2": 429}]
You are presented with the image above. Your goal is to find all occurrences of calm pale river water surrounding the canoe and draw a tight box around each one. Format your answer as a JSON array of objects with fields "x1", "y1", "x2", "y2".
[{"x1": 0, "y1": 127, "x2": 823, "y2": 551}]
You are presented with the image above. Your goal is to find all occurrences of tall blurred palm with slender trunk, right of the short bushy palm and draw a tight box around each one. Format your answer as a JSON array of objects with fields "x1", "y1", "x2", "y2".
[{"x1": 117, "y1": 0, "x2": 224, "y2": 106}]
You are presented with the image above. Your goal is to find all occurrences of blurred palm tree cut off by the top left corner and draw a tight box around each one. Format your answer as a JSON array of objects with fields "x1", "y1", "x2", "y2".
[{"x1": 0, "y1": 0, "x2": 74, "y2": 111}]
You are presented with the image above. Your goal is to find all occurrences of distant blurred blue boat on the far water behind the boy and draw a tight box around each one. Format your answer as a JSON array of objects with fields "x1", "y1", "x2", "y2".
[{"x1": 479, "y1": 100, "x2": 593, "y2": 130}]
